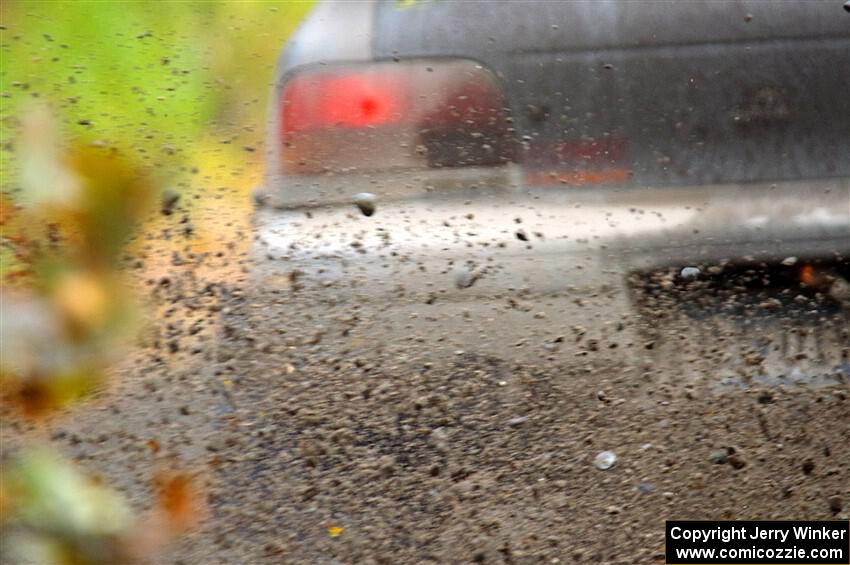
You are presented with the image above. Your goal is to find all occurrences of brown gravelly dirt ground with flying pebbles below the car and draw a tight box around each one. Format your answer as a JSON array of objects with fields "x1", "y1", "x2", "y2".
[{"x1": 3, "y1": 231, "x2": 850, "y2": 564}]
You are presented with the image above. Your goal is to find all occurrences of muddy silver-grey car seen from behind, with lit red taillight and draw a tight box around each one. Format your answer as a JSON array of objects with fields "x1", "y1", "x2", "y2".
[{"x1": 254, "y1": 0, "x2": 850, "y2": 376}]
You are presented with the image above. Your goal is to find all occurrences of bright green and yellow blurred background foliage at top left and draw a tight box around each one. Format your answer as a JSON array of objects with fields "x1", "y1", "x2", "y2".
[{"x1": 0, "y1": 0, "x2": 313, "y2": 276}]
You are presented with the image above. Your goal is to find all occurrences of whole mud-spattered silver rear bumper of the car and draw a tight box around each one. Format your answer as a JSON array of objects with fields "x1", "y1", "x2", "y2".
[{"x1": 251, "y1": 174, "x2": 850, "y2": 366}]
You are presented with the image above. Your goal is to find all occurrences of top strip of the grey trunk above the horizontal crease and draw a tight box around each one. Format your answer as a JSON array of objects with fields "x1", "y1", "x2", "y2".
[{"x1": 375, "y1": 0, "x2": 848, "y2": 55}]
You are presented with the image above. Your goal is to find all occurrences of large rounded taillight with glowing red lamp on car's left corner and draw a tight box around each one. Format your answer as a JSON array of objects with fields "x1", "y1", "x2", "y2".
[{"x1": 278, "y1": 61, "x2": 514, "y2": 175}]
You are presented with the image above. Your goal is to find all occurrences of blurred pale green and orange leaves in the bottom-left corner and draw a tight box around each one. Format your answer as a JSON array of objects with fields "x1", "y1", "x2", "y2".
[{"x1": 0, "y1": 449, "x2": 204, "y2": 565}]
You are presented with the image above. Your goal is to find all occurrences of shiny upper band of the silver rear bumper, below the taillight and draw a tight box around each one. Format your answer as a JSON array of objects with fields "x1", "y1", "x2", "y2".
[{"x1": 255, "y1": 176, "x2": 850, "y2": 297}]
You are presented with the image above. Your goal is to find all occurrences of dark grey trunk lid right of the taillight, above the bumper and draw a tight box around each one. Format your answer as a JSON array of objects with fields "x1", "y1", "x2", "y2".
[{"x1": 375, "y1": 1, "x2": 850, "y2": 186}]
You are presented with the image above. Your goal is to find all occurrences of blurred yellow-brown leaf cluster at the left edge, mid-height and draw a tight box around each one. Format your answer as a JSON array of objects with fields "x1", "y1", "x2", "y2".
[{"x1": 0, "y1": 106, "x2": 149, "y2": 417}]
